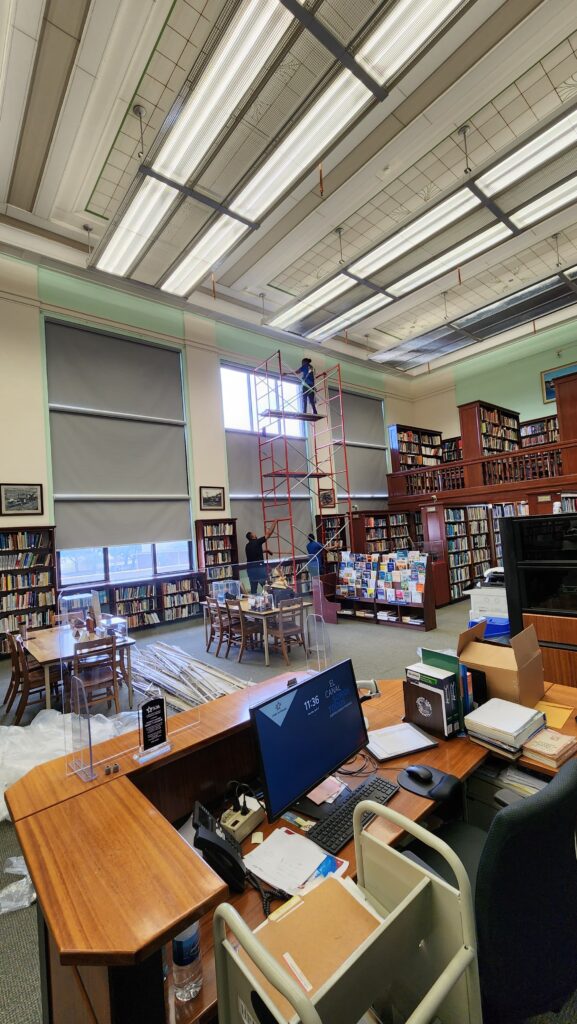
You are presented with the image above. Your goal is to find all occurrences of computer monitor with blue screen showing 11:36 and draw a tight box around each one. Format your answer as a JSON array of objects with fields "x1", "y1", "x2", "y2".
[{"x1": 250, "y1": 659, "x2": 368, "y2": 821}]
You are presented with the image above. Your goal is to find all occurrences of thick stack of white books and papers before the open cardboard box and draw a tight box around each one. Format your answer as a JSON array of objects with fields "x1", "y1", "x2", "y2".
[{"x1": 464, "y1": 697, "x2": 545, "y2": 761}]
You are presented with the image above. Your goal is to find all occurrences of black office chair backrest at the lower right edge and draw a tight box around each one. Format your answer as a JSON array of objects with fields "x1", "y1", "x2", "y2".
[{"x1": 476, "y1": 761, "x2": 577, "y2": 1024}]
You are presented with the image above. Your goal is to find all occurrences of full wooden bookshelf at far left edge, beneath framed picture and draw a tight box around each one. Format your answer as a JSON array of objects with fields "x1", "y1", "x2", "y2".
[{"x1": 0, "y1": 526, "x2": 56, "y2": 653}]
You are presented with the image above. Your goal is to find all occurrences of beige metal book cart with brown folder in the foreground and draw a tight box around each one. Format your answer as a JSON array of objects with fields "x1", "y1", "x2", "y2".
[{"x1": 214, "y1": 801, "x2": 483, "y2": 1024}]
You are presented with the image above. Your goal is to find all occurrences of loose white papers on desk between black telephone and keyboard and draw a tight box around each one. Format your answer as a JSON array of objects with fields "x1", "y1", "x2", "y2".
[{"x1": 244, "y1": 828, "x2": 327, "y2": 896}]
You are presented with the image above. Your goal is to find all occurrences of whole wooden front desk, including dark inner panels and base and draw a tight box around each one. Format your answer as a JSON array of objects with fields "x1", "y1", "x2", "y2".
[{"x1": 6, "y1": 672, "x2": 577, "y2": 1024}]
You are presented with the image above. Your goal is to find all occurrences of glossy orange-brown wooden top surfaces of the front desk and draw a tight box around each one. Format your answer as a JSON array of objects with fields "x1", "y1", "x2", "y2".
[{"x1": 6, "y1": 672, "x2": 577, "y2": 978}]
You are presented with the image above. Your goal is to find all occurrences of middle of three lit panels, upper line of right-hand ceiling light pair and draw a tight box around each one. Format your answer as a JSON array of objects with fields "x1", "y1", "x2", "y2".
[{"x1": 348, "y1": 187, "x2": 481, "y2": 278}]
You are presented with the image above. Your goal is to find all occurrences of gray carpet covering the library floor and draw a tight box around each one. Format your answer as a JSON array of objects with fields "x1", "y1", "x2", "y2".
[{"x1": 0, "y1": 602, "x2": 577, "y2": 1024}]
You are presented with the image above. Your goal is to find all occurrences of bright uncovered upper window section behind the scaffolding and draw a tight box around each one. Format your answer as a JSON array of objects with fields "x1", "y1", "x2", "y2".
[{"x1": 220, "y1": 367, "x2": 304, "y2": 437}]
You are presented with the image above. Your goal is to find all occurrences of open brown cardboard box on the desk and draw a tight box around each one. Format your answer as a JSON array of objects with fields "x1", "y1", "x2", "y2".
[{"x1": 457, "y1": 623, "x2": 545, "y2": 708}]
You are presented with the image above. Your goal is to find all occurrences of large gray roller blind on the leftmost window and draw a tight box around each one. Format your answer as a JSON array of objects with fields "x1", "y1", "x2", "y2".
[{"x1": 46, "y1": 323, "x2": 191, "y2": 550}]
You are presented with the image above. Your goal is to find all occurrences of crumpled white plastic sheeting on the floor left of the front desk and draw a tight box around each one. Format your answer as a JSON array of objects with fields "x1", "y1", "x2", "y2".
[{"x1": 0, "y1": 711, "x2": 138, "y2": 821}]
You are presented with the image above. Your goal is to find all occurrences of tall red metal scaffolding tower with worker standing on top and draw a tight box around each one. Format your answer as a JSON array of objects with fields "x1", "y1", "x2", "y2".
[{"x1": 253, "y1": 351, "x2": 353, "y2": 582}]
